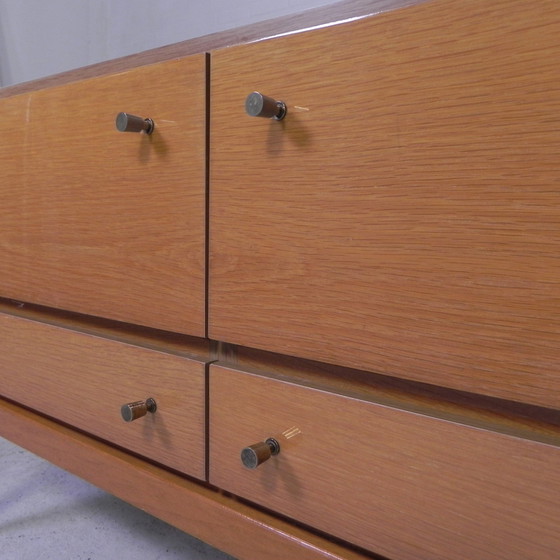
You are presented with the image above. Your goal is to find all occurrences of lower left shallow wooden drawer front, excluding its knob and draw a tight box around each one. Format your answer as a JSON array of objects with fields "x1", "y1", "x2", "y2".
[{"x1": 0, "y1": 314, "x2": 206, "y2": 479}]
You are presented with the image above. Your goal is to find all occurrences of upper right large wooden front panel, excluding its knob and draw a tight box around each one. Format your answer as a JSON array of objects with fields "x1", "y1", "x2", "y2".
[{"x1": 209, "y1": 0, "x2": 560, "y2": 407}]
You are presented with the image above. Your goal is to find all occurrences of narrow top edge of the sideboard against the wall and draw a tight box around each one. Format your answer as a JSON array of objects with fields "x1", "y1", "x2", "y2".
[{"x1": 0, "y1": 0, "x2": 422, "y2": 98}]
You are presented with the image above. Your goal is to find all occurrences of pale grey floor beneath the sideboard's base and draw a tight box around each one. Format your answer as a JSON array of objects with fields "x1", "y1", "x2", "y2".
[{"x1": 0, "y1": 438, "x2": 233, "y2": 560}]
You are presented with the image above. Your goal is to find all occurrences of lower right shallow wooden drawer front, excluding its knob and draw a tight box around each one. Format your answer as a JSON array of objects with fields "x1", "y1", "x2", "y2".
[{"x1": 209, "y1": 365, "x2": 560, "y2": 560}]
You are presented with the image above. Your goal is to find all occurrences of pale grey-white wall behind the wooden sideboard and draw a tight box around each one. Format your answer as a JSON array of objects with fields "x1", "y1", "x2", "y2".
[{"x1": 0, "y1": 0, "x2": 336, "y2": 86}]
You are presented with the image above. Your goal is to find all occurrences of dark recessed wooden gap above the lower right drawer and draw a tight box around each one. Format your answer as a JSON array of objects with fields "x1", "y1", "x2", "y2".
[{"x1": 231, "y1": 346, "x2": 560, "y2": 447}]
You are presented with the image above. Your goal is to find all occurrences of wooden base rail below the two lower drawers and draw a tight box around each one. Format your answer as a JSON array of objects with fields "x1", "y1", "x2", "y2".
[{"x1": 0, "y1": 399, "x2": 371, "y2": 560}]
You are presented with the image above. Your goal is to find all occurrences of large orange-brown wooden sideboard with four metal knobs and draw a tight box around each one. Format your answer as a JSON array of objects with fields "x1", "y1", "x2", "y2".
[{"x1": 0, "y1": 0, "x2": 560, "y2": 560}]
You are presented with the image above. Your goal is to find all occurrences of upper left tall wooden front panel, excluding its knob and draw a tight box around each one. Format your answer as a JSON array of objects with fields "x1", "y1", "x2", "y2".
[{"x1": 0, "y1": 55, "x2": 206, "y2": 336}]
